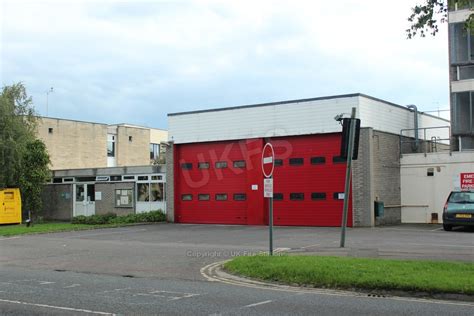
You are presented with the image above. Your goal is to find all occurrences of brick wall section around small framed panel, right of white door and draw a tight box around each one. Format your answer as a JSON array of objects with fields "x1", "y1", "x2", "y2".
[{"x1": 95, "y1": 182, "x2": 136, "y2": 216}]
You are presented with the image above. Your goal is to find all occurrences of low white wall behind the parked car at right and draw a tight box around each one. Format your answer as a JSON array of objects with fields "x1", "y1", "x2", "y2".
[{"x1": 400, "y1": 152, "x2": 474, "y2": 223}]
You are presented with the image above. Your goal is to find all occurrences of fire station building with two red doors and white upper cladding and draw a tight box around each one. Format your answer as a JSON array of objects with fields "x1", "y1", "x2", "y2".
[{"x1": 166, "y1": 94, "x2": 449, "y2": 226}]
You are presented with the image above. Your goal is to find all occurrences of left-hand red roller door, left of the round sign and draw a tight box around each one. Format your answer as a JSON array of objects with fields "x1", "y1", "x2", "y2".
[{"x1": 175, "y1": 141, "x2": 248, "y2": 224}]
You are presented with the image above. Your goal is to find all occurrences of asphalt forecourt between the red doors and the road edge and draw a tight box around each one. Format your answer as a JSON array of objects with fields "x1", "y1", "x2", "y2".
[{"x1": 0, "y1": 223, "x2": 474, "y2": 280}]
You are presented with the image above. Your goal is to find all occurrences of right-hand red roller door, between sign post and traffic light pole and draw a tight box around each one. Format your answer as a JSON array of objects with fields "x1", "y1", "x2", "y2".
[{"x1": 271, "y1": 134, "x2": 352, "y2": 226}]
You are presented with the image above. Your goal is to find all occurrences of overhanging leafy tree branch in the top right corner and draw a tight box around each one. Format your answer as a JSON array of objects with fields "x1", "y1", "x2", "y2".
[{"x1": 406, "y1": 0, "x2": 474, "y2": 38}]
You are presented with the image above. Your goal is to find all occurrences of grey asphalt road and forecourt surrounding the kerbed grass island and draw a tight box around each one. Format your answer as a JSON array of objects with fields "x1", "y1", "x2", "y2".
[{"x1": 0, "y1": 224, "x2": 474, "y2": 315}]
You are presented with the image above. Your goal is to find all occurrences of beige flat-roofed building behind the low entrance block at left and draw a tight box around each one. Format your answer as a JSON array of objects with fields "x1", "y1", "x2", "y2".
[{"x1": 37, "y1": 117, "x2": 168, "y2": 170}]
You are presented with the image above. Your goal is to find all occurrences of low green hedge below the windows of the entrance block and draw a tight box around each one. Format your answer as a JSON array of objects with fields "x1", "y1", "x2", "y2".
[{"x1": 72, "y1": 210, "x2": 166, "y2": 225}]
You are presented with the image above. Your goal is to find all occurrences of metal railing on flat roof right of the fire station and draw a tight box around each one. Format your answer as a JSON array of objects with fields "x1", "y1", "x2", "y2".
[{"x1": 400, "y1": 126, "x2": 452, "y2": 158}]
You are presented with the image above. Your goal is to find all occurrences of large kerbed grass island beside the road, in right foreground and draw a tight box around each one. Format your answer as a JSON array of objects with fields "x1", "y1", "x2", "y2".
[{"x1": 224, "y1": 256, "x2": 474, "y2": 295}]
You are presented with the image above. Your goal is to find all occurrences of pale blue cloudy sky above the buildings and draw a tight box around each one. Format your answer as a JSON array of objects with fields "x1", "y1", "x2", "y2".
[{"x1": 0, "y1": 0, "x2": 449, "y2": 129}]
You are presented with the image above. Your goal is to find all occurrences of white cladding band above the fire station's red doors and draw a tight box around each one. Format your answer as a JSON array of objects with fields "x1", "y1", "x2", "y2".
[{"x1": 168, "y1": 95, "x2": 449, "y2": 144}]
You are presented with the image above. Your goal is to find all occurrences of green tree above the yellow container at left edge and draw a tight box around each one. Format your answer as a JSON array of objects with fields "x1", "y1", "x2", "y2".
[{"x1": 0, "y1": 83, "x2": 49, "y2": 215}]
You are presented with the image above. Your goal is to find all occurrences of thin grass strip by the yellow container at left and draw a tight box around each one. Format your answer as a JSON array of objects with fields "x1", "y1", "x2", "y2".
[{"x1": 0, "y1": 222, "x2": 125, "y2": 237}]
